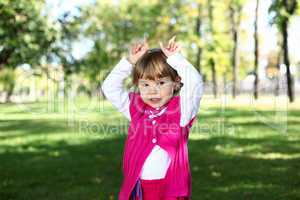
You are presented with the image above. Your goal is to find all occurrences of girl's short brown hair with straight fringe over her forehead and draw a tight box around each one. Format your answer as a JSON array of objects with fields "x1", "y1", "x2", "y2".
[{"x1": 132, "y1": 48, "x2": 182, "y2": 93}]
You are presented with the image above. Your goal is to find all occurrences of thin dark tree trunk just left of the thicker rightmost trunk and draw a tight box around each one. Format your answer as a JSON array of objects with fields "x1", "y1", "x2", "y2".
[{"x1": 253, "y1": 0, "x2": 259, "y2": 99}]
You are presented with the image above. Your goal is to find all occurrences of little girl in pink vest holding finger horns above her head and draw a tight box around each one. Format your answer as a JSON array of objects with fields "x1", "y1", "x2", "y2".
[{"x1": 101, "y1": 37, "x2": 203, "y2": 200}]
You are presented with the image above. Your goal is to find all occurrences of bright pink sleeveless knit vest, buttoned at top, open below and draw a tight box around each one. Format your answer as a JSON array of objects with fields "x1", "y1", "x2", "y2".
[{"x1": 119, "y1": 92, "x2": 195, "y2": 200}]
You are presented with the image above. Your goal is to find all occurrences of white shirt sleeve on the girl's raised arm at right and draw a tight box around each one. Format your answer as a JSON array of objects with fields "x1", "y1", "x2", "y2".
[{"x1": 167, "y1": 53, "x2": 203, "y2": 127}]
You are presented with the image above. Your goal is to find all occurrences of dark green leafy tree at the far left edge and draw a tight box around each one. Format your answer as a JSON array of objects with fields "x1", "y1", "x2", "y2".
[{"x1": 0, "y1": 0, "x2": 56, "y2": 101}]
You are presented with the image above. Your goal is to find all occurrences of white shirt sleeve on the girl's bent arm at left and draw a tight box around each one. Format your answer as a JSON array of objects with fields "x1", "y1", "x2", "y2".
[{"x1": 101, "y1": 58, "x2": 133, "y2": 120}]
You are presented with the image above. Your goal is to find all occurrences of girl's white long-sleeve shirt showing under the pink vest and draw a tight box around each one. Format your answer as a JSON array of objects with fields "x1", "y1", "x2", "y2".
[{"x1": 101, "y1": 53, "x2": 203, "y2": 180}]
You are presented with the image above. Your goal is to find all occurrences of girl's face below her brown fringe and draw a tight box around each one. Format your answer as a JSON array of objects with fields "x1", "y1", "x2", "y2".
[{"x1": 138, "y1": 76, "x2": 178, "y2": 108}]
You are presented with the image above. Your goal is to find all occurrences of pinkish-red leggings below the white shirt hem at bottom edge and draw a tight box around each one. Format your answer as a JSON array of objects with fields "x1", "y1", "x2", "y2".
[{"x1": 141, "y1": 179, "x2": 188, "y2": 200}]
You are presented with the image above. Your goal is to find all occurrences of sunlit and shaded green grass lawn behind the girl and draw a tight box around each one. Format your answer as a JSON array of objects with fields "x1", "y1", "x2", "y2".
[{"x1": 0, "y1": 96, "x2": 300, "y2": 200}]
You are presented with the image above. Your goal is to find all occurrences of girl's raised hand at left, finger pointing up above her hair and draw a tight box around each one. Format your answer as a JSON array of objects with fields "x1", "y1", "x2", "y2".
[{"x1": 128, "y1": 38, "x2": 149, "y2": 65}]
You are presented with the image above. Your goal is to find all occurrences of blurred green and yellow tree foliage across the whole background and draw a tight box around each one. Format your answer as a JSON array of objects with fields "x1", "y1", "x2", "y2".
[{"x1": 0, "y1": 0, "x2": 300, "y2": 97}]
